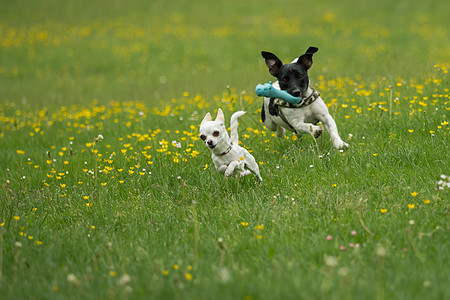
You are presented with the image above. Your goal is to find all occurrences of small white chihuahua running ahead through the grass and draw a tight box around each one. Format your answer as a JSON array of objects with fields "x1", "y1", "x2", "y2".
[{"x1": 200, "y1": 108, "x2": 262, "y2": 181}]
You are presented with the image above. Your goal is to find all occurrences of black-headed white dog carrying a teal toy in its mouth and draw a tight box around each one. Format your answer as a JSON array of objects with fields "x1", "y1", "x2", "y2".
[{"x1": 261, "y1": 47, "x2": 348, "y2": 149}]
